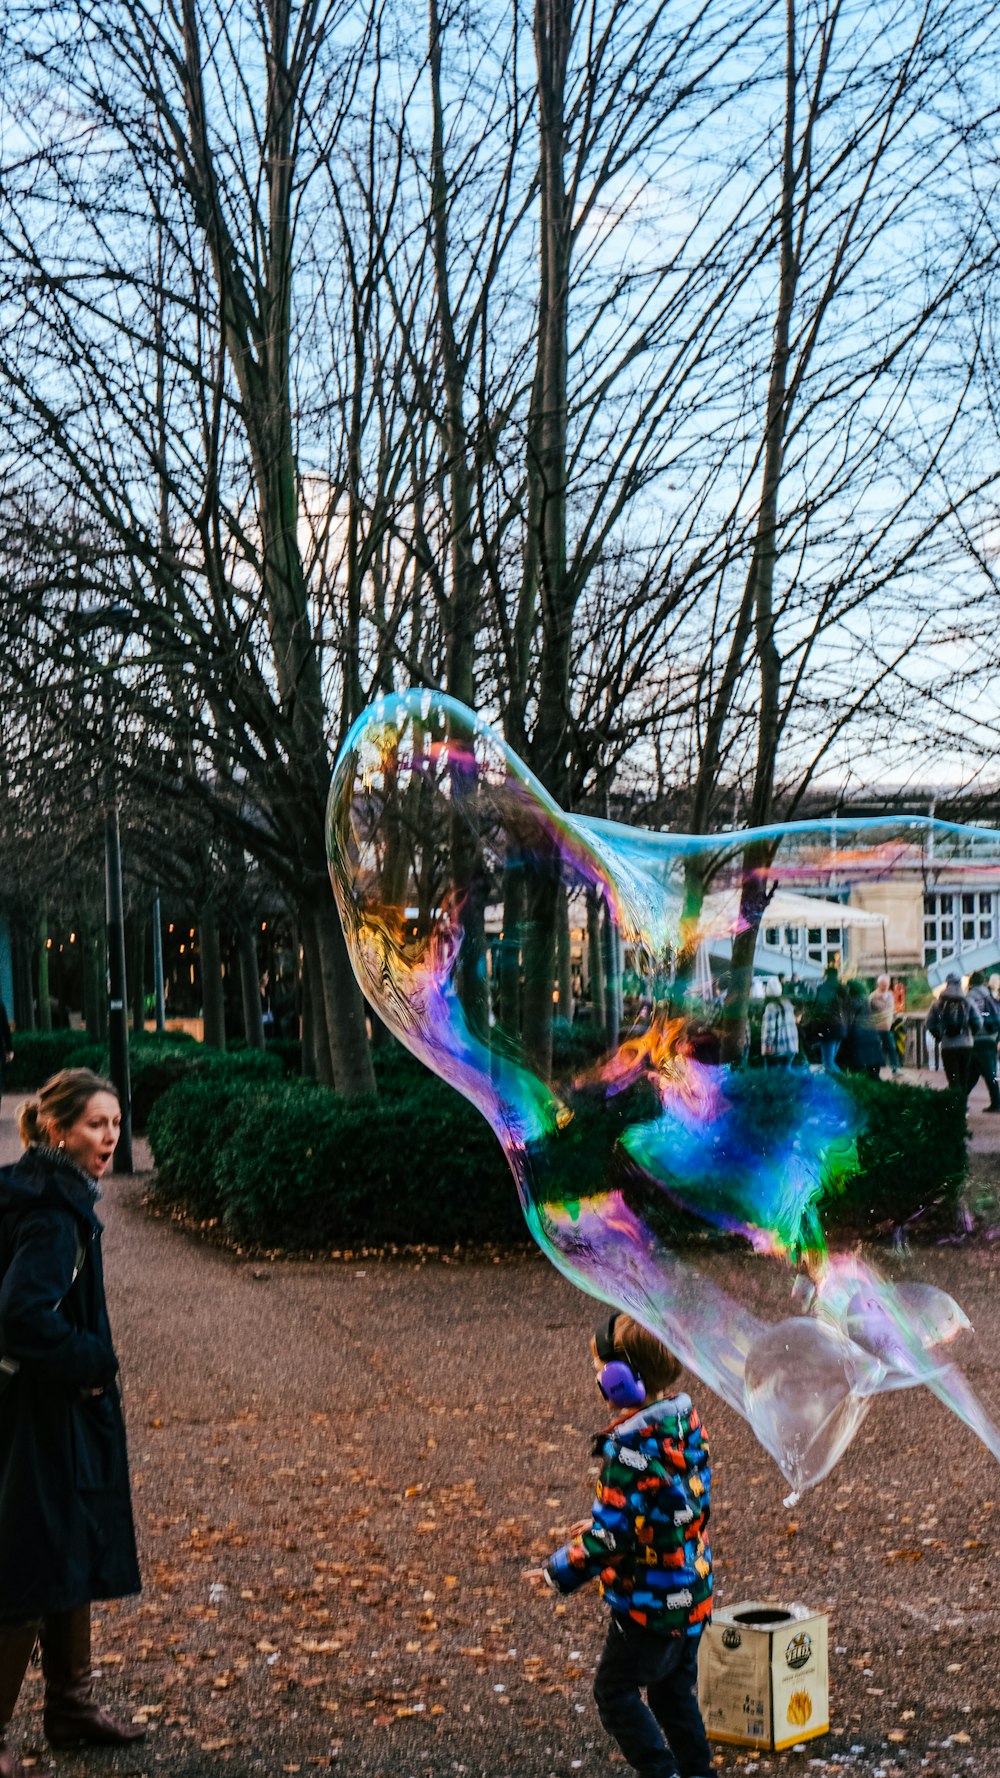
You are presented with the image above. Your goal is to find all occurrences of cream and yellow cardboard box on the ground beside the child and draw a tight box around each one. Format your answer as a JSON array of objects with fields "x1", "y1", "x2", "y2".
[{"x1": 698, "y1": 1598, "x2": 829, "y2": 1751}]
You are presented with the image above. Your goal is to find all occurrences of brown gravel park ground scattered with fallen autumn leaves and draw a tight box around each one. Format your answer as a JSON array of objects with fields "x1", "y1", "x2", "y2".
[{"x1": 0, "y1": 1066, "x2": 1000, "y2": 1778}]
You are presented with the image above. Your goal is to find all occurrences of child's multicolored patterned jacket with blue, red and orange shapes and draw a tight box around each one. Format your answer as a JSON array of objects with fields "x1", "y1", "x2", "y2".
[{"x1": 546, "y1": 1396, "x2": 712, "y2": 1636}]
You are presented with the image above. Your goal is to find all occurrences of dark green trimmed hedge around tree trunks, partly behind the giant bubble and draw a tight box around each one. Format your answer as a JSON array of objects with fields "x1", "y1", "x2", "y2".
[{"x1": 149, "y1": 1056, "x2": 966, "y2": 1250}]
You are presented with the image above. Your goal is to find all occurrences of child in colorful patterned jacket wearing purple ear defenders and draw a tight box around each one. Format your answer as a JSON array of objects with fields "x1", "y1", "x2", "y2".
[{"x1": 525, "y1": 1314, "x2": 712, "y2": 1778}]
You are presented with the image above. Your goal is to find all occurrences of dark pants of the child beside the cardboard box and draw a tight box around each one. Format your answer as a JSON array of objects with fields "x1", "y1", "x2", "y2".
[{"x1": 594, "y1": 1618, "x2": 712, "y2": 1778}]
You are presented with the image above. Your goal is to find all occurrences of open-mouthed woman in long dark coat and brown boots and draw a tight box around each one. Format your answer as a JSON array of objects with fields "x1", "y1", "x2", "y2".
[{"x1": 0, "y1": 1069, "x2": 144, "y2": 1778}]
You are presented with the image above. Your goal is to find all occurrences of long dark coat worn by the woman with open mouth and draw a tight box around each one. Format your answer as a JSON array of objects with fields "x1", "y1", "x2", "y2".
[{"x1": 0, "y1": 1149, "x2": 141, "y2": 1623}]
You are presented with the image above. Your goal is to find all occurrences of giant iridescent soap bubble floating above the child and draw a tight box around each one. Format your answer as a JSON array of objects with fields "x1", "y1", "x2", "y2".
[{"x1": 327, "y1": 692, "x2": 1000, "y2": 1492}]
